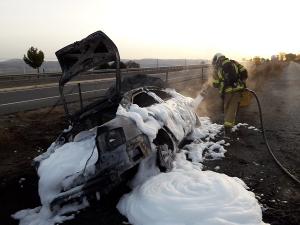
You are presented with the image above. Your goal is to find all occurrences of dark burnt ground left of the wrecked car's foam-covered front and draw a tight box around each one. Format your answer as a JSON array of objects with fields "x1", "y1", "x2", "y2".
[{"x1": 0, "y1": 109, "x2": 65, "y2": 225}]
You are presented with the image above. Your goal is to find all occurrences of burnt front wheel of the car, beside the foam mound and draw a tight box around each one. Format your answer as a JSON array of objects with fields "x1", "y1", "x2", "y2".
[{"x1": 157, "y1": 144, "x2": 175, "y2": 172}]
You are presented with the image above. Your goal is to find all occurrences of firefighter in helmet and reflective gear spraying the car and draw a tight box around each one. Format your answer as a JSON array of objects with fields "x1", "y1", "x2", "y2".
[{"x1": 212, "y1": 53, "x2": 248, "y2": 137}]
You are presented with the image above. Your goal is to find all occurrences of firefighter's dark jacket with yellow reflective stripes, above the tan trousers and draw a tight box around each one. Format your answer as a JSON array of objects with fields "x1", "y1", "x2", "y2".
[{"x1": 213, "y1": 57, "x2": 248, "y2": 95}]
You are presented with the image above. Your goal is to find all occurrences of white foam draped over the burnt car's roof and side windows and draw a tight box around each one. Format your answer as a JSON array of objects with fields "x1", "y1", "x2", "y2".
[{"x1": 117, "y1": 89, "x2": 196, "y2": 142}]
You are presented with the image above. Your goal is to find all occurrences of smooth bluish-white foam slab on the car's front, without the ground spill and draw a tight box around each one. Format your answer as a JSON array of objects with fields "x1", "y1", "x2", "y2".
[{"x1": 38, "y1": 137, "x2": 98, "y2": 205}]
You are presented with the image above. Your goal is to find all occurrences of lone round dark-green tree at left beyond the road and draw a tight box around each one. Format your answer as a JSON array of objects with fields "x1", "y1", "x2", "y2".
[{"x1": 23, "y1": 46, "x2": 44, "y2": 74}]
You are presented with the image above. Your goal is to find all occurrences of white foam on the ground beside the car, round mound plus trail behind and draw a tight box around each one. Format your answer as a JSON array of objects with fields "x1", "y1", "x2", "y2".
[{"x1": 117, "y1": 117, "x2": 265, "y2": 225}]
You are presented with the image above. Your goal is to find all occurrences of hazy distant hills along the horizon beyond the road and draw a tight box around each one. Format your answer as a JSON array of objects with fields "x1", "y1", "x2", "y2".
[{"x1": 0, "y1": 59, "x2": 208, "y2": 74}]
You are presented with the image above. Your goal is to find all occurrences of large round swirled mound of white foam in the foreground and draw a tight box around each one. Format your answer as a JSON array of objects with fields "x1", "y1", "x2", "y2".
[{"x1": 117, "y1": 169, "x2": 264, "y2": 225}]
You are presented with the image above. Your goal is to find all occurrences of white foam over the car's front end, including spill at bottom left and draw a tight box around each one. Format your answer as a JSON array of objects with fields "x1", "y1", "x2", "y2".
[{"x1": 12, "y1": 135, "x2": 98, "y2": 225}]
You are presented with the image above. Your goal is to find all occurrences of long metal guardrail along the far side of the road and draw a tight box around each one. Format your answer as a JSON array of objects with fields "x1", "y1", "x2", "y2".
[{"x1": 0, "y1": 64, "x2": 210, "y2": 82}]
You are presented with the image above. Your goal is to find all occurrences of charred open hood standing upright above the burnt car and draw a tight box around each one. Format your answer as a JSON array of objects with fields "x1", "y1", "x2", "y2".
[{"x1": 55, "y1": 31, "x2": 121, "y2": 88}]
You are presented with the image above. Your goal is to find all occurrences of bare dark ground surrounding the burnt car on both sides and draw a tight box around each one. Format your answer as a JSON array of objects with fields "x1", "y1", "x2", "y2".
[{"x1": 0, "y1": 64, "x2": 300, "y2": 225}]
